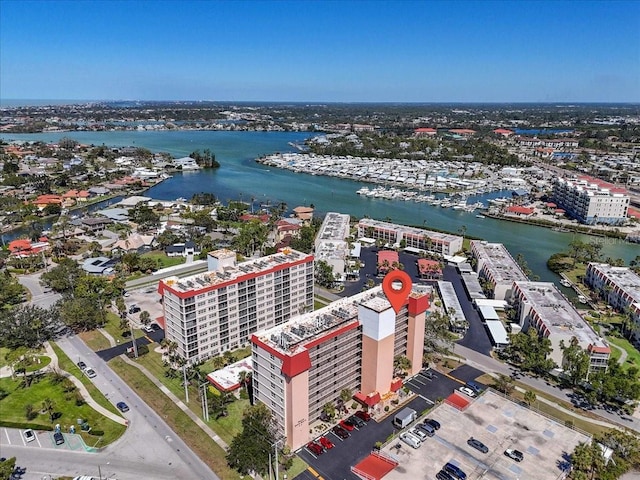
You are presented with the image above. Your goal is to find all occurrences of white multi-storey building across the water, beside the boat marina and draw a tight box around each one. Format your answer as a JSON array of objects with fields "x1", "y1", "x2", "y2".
[{"x1": 553, "y1": 176, "x2": 630, "y2": 225}]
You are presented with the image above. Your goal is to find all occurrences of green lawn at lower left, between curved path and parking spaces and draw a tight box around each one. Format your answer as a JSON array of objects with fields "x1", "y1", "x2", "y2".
[{"x1": 0, "y1": 374, "x2": 126, "y2": 446}]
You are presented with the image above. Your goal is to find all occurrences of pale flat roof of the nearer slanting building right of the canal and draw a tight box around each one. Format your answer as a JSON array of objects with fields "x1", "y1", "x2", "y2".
[{"x1": 516, "y1": 282, "x2": 609, "y2": 348}]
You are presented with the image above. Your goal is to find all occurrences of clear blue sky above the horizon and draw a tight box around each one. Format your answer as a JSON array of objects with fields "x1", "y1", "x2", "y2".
[{"x1": 0, "y1": 0, "x2": 640, "y2": 102}]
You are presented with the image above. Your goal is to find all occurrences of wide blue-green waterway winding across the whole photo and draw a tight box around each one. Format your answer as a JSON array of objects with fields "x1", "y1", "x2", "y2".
[{"x1": 3, "y1": 131, "x2": 640, "y2": 280}]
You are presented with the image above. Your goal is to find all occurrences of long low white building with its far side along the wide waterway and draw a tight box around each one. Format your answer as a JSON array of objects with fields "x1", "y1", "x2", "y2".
[{"x1": 358, "y1": 218, "x2": 462, "y2": 256}]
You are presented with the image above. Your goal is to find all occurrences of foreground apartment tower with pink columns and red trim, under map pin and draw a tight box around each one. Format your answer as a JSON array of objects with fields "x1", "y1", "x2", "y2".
[{"x1": 251, "y1": 287, "x2": 429, "y2": 449}]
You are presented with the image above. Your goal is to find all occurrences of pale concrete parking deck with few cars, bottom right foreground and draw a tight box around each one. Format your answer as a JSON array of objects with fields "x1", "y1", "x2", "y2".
[{"x1": 383, "y1": 391, "x2": 589, "y2": 480}]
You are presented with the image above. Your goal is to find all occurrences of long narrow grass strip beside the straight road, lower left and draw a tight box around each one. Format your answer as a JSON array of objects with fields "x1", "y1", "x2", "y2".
[{"x1": 109, "y1": 358, "x2": 242, "y2": 480}]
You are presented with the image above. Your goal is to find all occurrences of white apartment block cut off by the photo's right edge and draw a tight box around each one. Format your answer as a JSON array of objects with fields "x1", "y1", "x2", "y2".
[{"x1": 585, "y1": 263, "x2": 640, "y2": 341}]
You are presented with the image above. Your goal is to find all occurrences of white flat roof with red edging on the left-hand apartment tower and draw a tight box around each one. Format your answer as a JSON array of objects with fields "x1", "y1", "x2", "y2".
[{"x1": 162, "y1": 250, "x2": 312, "y2": 292}]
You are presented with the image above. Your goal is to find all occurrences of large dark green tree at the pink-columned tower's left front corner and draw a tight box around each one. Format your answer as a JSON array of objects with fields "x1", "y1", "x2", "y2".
[{"x1": 227, "y1": 403, "x2": 276, "y2": 475}]
